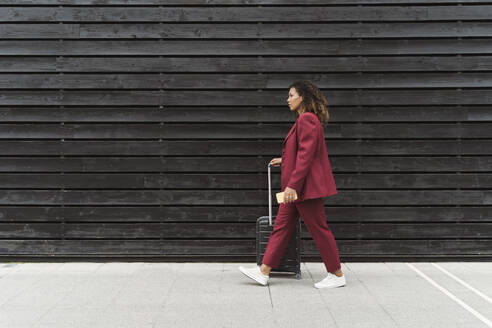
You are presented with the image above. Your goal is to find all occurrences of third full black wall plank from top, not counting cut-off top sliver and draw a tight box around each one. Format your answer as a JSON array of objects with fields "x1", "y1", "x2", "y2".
[{"x1": 0, "y1": 38, "x2": 492, "y2": 56}]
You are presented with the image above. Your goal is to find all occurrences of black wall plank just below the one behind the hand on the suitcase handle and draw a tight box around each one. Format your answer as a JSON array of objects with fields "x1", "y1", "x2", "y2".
[{"x1": 0, "y1": 172, "x2": 492, "y2": 190}]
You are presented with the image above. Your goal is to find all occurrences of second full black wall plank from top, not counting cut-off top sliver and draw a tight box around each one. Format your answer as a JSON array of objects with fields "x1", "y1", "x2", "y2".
[{"x1": 0, "y1": 21, "x2": 492, "y2": 39}]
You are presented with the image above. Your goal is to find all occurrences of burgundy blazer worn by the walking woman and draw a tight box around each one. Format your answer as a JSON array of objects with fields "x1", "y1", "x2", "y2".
[{"x1": 281, "y1": 112, "x2": 338, "y2": 201}]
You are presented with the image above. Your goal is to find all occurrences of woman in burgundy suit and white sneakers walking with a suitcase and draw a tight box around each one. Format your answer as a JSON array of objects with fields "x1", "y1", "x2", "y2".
[{"x1": 239, "y1": 80, "x2": 345, "y2": 288}]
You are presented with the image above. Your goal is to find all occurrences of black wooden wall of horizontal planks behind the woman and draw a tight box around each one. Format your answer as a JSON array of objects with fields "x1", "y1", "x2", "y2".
[{"x1": 0, "y1": 0, "x2": 492, "y2": 260}]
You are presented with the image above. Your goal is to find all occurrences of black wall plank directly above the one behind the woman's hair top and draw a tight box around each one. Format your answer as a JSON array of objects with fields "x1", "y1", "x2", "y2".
[{"x1": 0, "y1": 55, "x2": 492, "y2": 73}]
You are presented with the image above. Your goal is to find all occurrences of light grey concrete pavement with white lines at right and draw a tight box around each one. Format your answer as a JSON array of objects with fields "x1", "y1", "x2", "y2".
[{"x1": 0, "y1": 262, "x2": 492, "y2": 328}]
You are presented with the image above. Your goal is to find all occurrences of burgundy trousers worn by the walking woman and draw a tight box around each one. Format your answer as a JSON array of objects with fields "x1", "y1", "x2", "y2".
[{"x1": 262, "y1": 198, "x2": 341, "y2": 272}]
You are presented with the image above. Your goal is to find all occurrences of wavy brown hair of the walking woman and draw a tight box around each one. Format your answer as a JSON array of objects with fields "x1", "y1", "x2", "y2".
[{"x1": 289, "y1": 80, "x2": 330, "y2": 126}]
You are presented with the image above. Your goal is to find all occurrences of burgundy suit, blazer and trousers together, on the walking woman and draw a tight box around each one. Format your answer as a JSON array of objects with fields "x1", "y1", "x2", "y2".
[{"x1": 262, "y1": 112, "x2": 340, "y2": 272}]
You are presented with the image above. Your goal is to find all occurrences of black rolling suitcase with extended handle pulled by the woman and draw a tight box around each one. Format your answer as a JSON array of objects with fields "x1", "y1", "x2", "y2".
[{"x1": 256, "y1": 163, "x2": 301, "y2": 279}]
